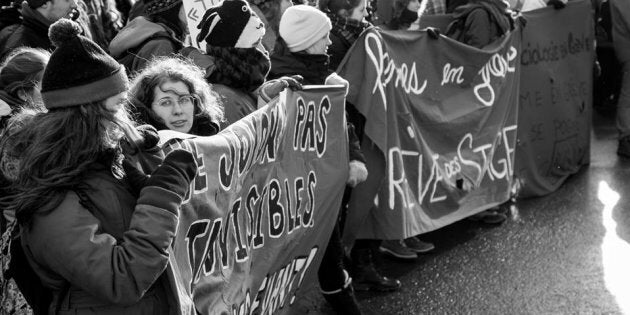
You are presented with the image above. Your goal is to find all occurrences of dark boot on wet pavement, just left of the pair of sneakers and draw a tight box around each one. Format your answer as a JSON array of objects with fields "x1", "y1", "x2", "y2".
[{"x1": 351, "y1": 248, "x2": 400, "y2": 291}]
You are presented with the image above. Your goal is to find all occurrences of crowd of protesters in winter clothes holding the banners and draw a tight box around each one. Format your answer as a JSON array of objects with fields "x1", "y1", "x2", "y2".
[{"x1": 0, "y1": 0, "x2": 630, "y2": 314}]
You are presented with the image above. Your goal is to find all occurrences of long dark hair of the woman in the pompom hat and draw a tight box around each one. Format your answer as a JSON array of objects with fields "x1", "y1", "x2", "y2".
[{"x1": 0, "y1": 102, "x2": 132, "y2": 228}]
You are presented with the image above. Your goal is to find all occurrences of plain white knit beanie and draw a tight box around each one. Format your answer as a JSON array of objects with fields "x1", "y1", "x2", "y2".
[{"x1": 280, "y1": 4, "x2": 332, "y2": 52}]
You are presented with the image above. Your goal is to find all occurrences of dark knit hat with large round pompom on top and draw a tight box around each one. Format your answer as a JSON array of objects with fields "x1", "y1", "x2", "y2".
[{"x1": 41, "y1": 19, "x2": 129, "y2": 109}]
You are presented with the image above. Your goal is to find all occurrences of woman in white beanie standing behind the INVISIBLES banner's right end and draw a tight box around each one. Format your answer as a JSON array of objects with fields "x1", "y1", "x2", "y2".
[{"x1": 270, "y1": 5, "x2": 367, "y2": 314}]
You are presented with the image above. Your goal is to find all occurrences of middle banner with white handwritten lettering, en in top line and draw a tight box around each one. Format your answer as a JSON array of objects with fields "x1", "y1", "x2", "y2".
[{"x1": 339, "y1": 29, "x2": 520, "y2": 241}]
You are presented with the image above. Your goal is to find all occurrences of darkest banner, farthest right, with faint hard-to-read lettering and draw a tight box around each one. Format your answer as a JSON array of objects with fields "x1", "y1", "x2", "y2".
[{"x1": 515, "y1": 0, "x2": 595, "y2": 197}]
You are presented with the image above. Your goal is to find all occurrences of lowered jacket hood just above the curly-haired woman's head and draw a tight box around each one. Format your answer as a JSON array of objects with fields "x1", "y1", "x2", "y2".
[{"x1": 109, "y1": 16, "x2": 183, "y2": 75}]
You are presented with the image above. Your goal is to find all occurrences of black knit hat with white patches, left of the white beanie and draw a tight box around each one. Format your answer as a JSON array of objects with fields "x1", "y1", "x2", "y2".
[{"x1": 197, "y1": 0, "x2": 265, "y2": 48}]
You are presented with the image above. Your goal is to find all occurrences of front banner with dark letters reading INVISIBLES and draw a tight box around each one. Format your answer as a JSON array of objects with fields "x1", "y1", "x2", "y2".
[{"x1": 160, "y1": 86, "x2": 348, "y2": 314}]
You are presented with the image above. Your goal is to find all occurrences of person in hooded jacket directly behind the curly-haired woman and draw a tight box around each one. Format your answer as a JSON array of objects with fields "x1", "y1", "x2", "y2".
[{"x1": 109, "y1": 0, "x2": 188, "y2": 75}]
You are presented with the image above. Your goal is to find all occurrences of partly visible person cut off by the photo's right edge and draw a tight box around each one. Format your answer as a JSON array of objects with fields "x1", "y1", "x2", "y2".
[{"x1": 610, "y1": 0, "x2": 630, "y2": 158}]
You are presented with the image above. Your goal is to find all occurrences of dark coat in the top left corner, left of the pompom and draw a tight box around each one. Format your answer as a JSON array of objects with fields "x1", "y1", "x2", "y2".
[{"x1": 0, "y1": 1, "x2": 53, "y2": 59}]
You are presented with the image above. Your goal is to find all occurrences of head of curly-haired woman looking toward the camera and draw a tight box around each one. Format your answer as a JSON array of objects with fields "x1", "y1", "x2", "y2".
[{"x1": 129, "y1": 57, "x2": 223, "y2": 136}]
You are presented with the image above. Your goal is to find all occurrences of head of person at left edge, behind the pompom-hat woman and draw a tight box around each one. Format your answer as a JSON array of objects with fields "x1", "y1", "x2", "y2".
[{"x1": 0, "y1": 47, "x2": 50, "y2": 130}]
